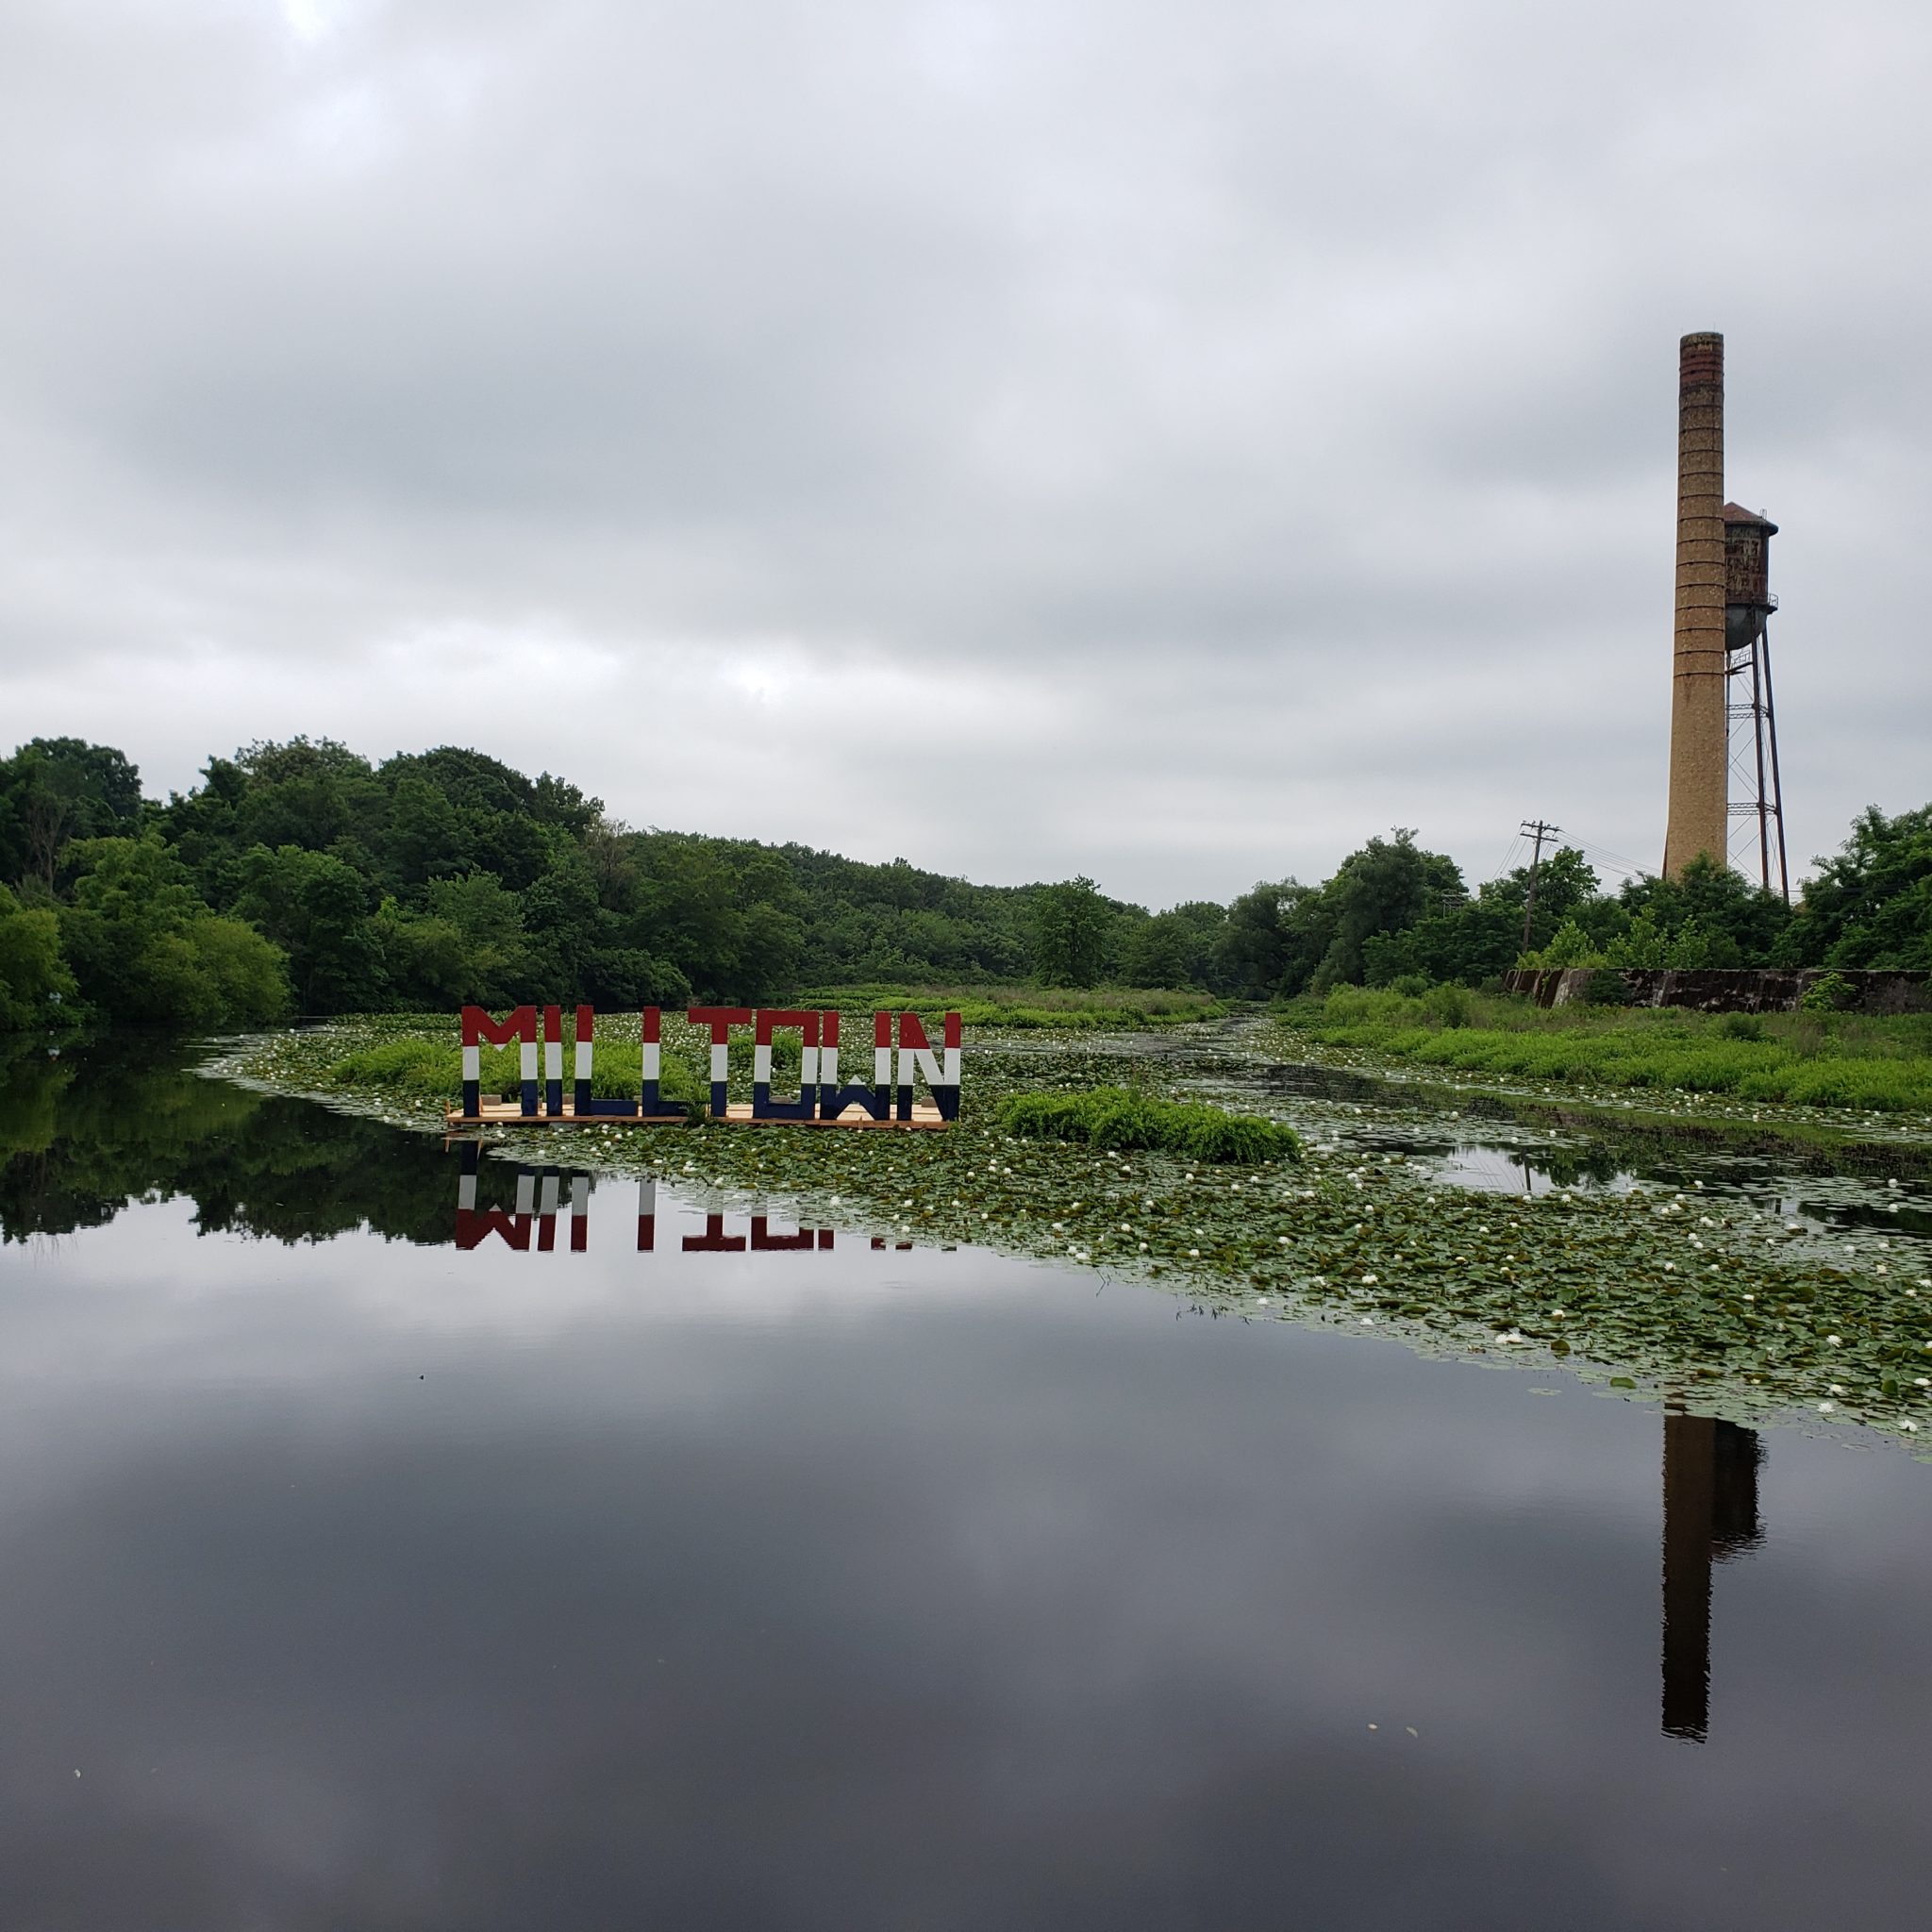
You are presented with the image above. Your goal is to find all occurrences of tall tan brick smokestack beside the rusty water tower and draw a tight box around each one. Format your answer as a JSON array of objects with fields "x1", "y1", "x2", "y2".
[{"x1": 1663, "y1": 334, "x2": 1731, "y2": 879}]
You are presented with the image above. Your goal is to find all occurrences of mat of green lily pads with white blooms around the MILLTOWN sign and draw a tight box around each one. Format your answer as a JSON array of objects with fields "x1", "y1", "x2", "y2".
[{"x1": 208, "y1": 1016, "x2": 1932, "y2": 1438}]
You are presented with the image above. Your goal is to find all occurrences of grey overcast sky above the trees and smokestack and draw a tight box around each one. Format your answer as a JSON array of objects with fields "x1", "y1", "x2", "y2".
[{"x1": 0, "y1": 0, "x2": 1932, "y2": 904}]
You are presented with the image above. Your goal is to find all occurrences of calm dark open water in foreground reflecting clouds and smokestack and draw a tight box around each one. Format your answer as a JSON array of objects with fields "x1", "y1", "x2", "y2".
[{"x1": 0, "y1": 1057, "x2": 1932, "y2": 1932}]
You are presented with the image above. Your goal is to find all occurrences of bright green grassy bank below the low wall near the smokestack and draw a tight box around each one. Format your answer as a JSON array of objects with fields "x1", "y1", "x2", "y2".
[{"x1": 1277, "y1": 988, "x2": 1932, "y2": 1113}]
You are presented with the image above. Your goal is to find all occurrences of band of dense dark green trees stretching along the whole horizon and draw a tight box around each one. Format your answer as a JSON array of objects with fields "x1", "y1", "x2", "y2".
[{"x1": 0, "y1": 738, "x2": 1932, "y2": 1030}]
